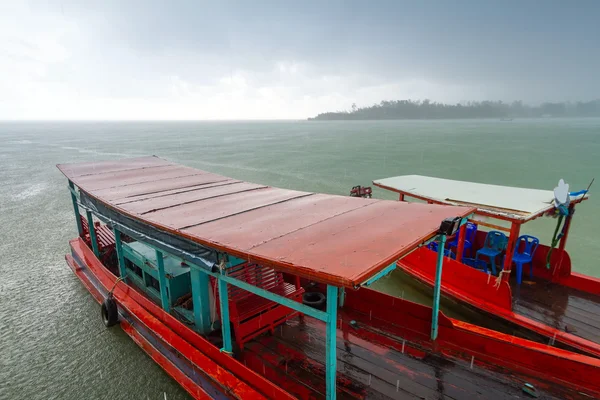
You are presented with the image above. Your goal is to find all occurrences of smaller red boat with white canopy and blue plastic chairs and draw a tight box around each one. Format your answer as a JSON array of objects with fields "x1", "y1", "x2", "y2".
[{"x1": 373, "y1": 175, "x2": 600, "y2": 357}]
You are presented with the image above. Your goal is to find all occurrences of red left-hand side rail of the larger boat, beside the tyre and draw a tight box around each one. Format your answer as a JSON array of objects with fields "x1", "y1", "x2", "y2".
[{"x1": 70, "y1": 239, "x2": 293, "y2": 399}]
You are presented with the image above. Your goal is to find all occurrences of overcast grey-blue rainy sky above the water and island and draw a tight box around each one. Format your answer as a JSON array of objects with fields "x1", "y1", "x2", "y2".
[{"x1": 0, "y1": 0, "x2": 600, "y2": 119}]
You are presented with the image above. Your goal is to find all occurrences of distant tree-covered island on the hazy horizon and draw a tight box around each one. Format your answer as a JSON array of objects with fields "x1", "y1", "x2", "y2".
[{"x1": 308, "y1": 100, "x2": 600, "y2": 121}]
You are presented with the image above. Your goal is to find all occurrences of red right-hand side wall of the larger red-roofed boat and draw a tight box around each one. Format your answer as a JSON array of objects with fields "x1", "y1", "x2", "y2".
[{"x1": 345, "y1": 288, "x2": 600, "y2": 396}]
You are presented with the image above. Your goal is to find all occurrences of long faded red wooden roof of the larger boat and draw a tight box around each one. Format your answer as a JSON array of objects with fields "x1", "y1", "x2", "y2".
[{"x1": 58, "y1": 157, "x2": 474, "y2": 287}]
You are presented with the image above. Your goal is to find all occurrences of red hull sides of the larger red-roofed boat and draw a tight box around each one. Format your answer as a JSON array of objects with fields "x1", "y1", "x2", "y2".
[{"x1": 66, "y1": 239, "x2": 600, "y2": 399}]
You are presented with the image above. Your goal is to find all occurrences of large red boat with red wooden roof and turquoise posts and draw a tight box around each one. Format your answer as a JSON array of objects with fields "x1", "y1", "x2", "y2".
[{"x1": 58, "y1": 156, "x2": 600, "y2": 399}]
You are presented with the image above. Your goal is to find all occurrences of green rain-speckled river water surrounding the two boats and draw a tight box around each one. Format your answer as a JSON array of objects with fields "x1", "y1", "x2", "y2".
[{"x1": 0, "y1": 119, "x2": 600, "y2": 400}]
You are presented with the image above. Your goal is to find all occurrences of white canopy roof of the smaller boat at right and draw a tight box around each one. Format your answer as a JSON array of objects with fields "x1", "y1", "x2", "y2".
[{"x1": 373, "y1": 175, "x2": 581, "y2": 221}]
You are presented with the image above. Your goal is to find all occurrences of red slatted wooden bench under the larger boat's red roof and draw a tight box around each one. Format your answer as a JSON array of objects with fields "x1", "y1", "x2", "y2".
[{"x1": 212, "y1": 263, "x2": 304, "y2": 349}]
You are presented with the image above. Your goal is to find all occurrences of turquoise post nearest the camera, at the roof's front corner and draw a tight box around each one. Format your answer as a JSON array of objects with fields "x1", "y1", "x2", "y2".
[{"x1": 325, "y1": 285, "x2": 338, "y2": 400}]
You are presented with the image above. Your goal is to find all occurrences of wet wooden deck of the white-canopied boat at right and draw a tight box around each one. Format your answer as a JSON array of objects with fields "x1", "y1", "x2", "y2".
[{"x1": 511, "y1": 278, "x2": 600, "y2": 343}]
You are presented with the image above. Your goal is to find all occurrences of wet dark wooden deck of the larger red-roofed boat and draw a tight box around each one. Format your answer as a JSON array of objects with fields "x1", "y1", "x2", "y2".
[{"x1": 240, "y1": 312, "x2": 577, "y2": 399}]
